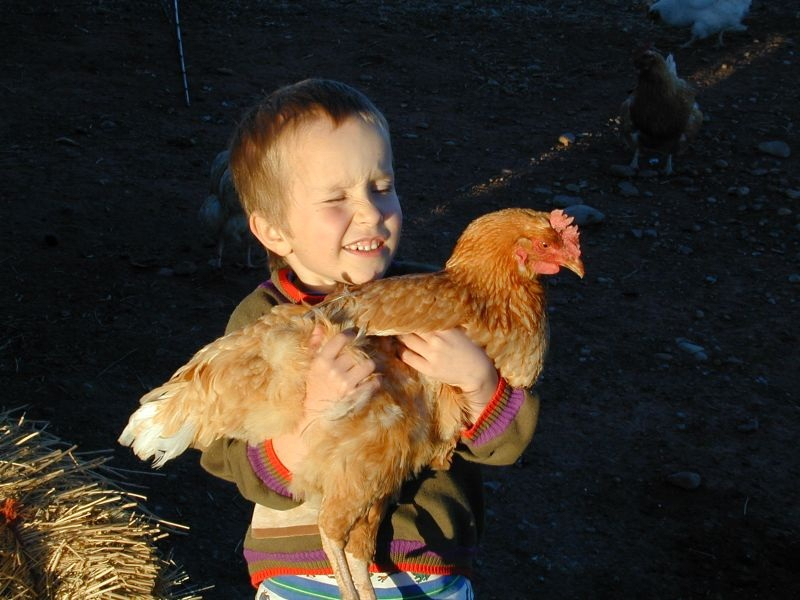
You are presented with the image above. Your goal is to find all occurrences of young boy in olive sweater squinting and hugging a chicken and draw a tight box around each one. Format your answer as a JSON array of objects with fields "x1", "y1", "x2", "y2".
[{"x1": 201, "y1": 79, "x2": 538, "y2": 600}]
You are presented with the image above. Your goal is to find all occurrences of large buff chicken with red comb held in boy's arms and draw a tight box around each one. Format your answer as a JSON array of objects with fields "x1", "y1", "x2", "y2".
[{"x1": 119, "y1": 208, "x2": 584, "y2": 599}]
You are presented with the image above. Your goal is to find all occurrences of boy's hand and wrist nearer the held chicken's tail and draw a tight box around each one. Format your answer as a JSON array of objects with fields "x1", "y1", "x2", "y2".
[{"x1": 272, "y1": 328, "x2": 380, "y2": 471}]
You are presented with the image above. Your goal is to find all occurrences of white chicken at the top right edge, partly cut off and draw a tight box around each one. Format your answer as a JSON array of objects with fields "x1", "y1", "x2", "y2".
[{"x1": 649, "y1": 0, "x2": 751, "y2": 48}]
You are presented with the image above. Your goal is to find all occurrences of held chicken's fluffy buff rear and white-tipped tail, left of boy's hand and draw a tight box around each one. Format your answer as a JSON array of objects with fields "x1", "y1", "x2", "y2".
[{"x1": 119, "y1": 308, "x2": 314, "y2": 466}]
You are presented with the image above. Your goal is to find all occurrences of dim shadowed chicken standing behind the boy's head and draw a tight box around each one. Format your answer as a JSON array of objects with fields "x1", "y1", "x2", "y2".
[{"x1": 197, "y1": 150, "x2": 254, "y2": 268}]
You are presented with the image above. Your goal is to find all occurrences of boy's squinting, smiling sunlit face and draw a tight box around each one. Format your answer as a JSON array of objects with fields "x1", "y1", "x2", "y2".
[{"x1": 279, "y1": 117, "x2": 403, "y2": 292}]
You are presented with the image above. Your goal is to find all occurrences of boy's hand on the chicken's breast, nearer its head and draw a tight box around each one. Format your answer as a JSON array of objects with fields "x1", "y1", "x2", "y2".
[{"x1": 397, "y1": 328, "x2": 498, "y2": 423}]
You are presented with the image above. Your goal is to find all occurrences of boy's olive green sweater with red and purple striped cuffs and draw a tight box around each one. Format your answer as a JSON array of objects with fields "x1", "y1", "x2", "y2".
[{"x1": 201, "y1": 270, "x2": 539, "y2": 587}]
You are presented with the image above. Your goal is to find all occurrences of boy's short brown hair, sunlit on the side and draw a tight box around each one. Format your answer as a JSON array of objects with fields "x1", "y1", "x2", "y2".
[{"x1": 230, "y1": 79, "x2": 389, "y2": 260}]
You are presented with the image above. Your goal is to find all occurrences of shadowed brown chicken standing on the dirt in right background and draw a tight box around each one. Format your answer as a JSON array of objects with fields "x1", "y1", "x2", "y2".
[{"x1": 620, "y1": 47, "x2": 703, "y2": 175}]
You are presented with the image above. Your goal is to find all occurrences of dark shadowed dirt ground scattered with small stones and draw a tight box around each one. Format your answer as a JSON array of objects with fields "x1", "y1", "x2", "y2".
[{"x1": 0, "y1": 0, "x2": 800, "y2": 600}]
